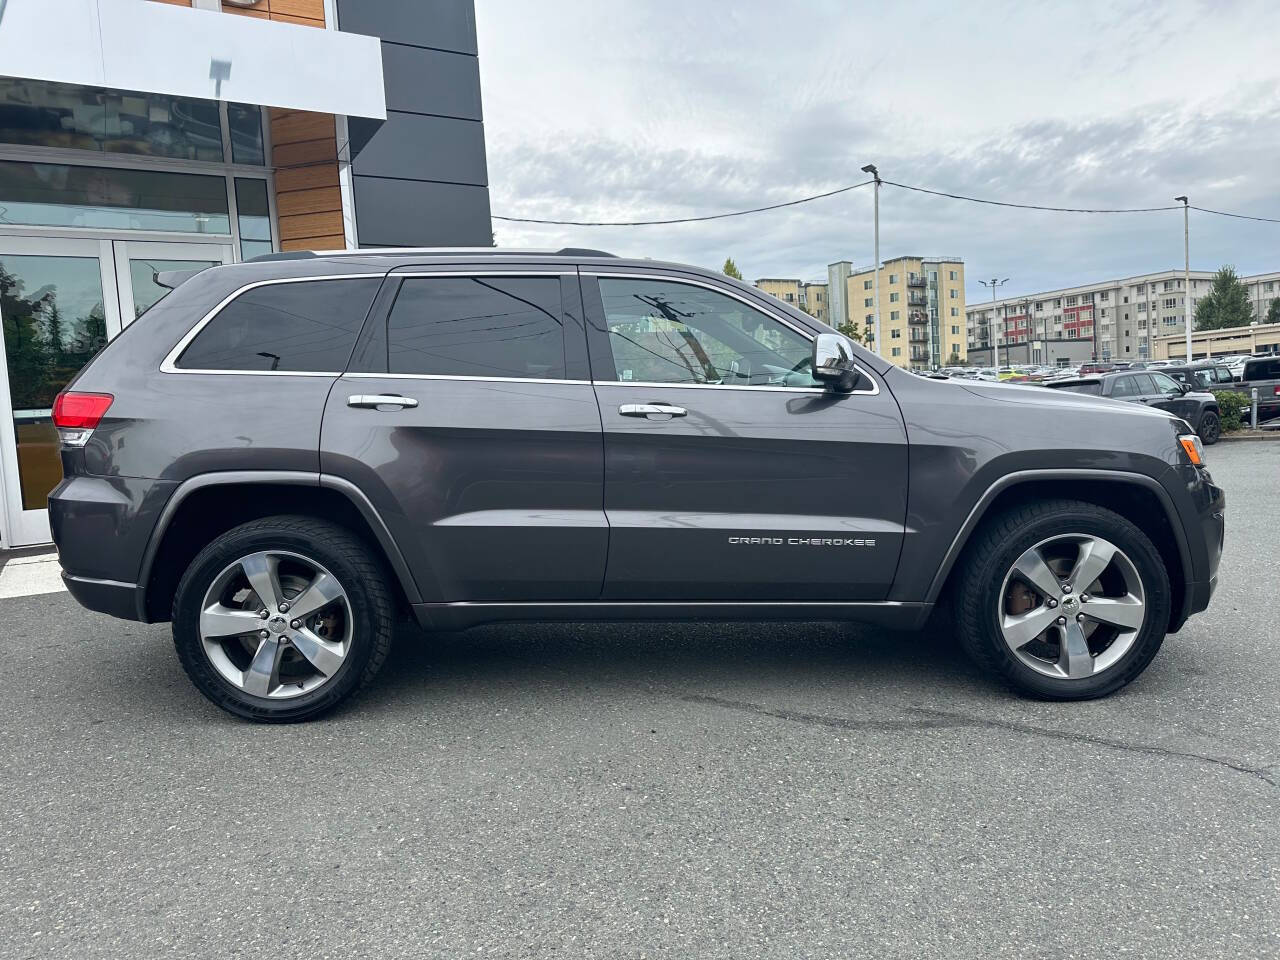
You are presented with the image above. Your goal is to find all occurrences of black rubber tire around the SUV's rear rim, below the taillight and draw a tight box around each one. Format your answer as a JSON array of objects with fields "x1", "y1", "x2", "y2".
[{"x1": 173, "y1": 516, "x2": 396, "y2": 723}]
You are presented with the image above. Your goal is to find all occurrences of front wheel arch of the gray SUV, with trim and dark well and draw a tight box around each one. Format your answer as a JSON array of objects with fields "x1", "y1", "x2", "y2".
[{"x1": 925, "y1": 470, "x2": 1193, "y2": 632}]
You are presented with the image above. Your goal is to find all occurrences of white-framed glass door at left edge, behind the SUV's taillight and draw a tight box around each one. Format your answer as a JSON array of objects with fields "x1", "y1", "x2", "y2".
[{"x1": 0, "y1": 237, "x2": 120, "y2": 547}]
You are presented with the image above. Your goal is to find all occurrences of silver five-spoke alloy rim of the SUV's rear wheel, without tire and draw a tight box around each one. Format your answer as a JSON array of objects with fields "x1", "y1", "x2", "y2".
[{"x1": 198, "y1": 550, "x2": 353, "y2": 700}]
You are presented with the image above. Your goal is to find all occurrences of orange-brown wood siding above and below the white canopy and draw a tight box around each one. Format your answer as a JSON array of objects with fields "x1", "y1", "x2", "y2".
[{"x1": 223, "y1": 0, "x2": 347, "y2": 250}]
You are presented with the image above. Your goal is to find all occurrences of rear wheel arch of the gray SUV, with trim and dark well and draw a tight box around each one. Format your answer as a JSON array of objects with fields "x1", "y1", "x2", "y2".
[{"x1": 137, "y1": 471, "x2": 421, "y2": 623}]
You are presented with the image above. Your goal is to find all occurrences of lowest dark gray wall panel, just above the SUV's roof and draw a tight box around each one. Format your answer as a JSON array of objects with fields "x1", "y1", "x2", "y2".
[{"x1": 353, "y1": 177, "x2": 493, "y2": 247}]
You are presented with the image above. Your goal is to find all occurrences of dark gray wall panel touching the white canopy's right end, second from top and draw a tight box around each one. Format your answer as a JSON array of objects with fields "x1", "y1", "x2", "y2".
[{"x1": 383, "y1": 44, "x2": 483, "y2": 120}]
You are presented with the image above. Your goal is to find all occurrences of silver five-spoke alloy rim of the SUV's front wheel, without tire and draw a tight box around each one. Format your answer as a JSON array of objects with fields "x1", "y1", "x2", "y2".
[{"x1": 996, "y1": 534, "x2": 1147, "y2": 680}]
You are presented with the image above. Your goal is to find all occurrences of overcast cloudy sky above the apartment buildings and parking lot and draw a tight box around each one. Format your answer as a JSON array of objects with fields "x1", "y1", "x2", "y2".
[{"x1": 476, "y1": 0, "x2": 1280, "y2": 301}]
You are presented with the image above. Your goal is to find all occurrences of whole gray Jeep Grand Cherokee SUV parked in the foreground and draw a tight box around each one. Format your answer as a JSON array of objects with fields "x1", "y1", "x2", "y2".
[{"x1": 49, "y1": 250, "x2": 1224, "y2": 722}]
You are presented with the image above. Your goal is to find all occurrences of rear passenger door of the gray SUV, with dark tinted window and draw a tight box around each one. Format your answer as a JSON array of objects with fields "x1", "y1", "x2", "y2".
[{"x1": 320, "y1": 266, "x2": 608, "y2": 603}]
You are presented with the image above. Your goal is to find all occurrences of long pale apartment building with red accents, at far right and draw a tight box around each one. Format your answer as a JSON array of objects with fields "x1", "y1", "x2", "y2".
[{"x1": 965, "y1": 270, "x2": 1280, "y2": 365}]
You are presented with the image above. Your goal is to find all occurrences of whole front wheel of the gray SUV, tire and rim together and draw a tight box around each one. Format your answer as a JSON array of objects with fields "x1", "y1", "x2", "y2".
[{"x1": 956, "y1": 500, "x2": 1170, "y2": 700}]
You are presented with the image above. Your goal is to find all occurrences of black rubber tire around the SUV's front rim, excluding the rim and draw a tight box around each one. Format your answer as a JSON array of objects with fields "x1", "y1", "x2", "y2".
[{"x1": 952, "y1": 499, "x2": 1170, "y2": 700}]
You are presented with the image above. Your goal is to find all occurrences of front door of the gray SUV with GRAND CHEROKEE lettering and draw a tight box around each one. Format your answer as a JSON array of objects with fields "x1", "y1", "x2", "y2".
[{"x1": 582, "y1": 274, "x2": 908, "y2": 602}]
